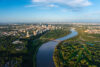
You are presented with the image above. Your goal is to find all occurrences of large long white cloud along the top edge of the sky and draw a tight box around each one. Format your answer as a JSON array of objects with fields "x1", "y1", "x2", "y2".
[{"x1": 32, "y1": 0, "x2": 92, "y2": 7}]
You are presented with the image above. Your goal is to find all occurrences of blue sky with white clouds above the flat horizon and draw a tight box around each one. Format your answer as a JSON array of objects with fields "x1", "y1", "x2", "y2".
[{"x1": 0, "y1": 0, "x2": 100, "y2": 23}]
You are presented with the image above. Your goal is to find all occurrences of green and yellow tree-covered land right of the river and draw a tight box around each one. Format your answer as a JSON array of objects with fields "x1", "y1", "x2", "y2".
[{"x1": 53, "y1": 28, "x2": 100, "y2": 67}]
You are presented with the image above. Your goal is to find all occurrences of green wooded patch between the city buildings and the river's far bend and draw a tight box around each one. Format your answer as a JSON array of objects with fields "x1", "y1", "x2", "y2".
[{"x1": 40, "y1": 28, "x2": 71, "y2": 40}]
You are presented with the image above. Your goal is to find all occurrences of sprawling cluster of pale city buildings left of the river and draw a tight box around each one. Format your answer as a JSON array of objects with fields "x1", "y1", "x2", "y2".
[{"x1": 0, "y1": 24, "x2": 61, "y2": 37}]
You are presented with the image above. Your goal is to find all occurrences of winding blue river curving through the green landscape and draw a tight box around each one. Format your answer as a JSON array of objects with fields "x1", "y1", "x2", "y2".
[{"x1": 36, "y1": 29, "x2": 78, "y2": 67}]
